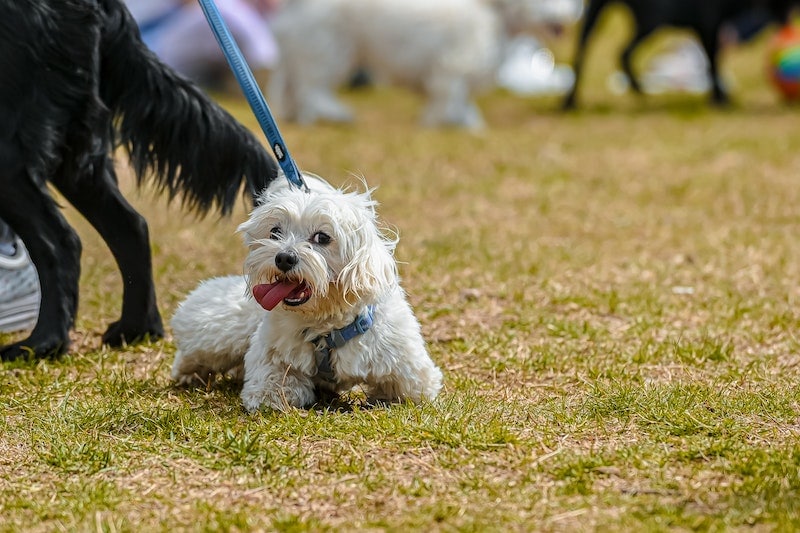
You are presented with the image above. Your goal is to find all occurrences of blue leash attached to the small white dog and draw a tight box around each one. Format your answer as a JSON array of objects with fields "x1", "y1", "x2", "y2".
[{"x1": 198, "y1": 0, "x2": 308, "y2": 192}]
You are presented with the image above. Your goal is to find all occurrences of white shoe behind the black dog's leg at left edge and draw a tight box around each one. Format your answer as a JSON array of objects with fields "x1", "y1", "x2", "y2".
[{"x1": 0, "y1": 240, "x2": 41, "y2": 333}]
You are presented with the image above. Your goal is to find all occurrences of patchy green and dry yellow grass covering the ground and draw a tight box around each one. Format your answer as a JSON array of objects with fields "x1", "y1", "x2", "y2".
[{"x1": 0, "y1": 13, "x2": 800, "y2": 531}]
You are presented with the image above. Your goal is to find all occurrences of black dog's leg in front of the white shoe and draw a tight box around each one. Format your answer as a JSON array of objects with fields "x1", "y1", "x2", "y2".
[{"x1": 0, "y1": 150, "x2": 81, "y2": 361}]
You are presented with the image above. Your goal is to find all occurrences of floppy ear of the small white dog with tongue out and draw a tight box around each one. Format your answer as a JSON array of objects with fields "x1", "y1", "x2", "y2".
[{"x1": 338, "y1": 192, "x2": 397, "y2": 300}]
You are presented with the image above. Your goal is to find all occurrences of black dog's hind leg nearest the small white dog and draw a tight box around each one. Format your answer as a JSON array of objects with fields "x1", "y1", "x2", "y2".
[{"x1": 53, "y1": 152, "x2": 164, "y2": 346}]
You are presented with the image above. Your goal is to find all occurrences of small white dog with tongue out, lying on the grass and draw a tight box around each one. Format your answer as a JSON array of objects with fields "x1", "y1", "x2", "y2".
[{"x1": 172, "y1": 175, "x2": 442, "y2": 411}]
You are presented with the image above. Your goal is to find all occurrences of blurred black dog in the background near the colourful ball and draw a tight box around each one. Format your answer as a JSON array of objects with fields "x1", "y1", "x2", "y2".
[{"x1": 563, "y1": 0, "x2": 790, "y2": 109}]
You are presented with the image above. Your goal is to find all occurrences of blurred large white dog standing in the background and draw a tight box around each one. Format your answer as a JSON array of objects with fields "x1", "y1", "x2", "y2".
[{"x1": 269, "y1": 0, "x2": 580, "y2": 129}]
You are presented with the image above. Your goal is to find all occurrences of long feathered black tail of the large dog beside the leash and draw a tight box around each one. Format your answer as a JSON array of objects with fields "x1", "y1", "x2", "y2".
[{"x1": 100, "y1": 0, "x2": 277, "y2": 214}]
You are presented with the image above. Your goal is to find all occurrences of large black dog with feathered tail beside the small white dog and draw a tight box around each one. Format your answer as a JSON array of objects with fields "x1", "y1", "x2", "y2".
[{"x1": 0, "y1": 0, "x2": 277, "y2": 360}]
